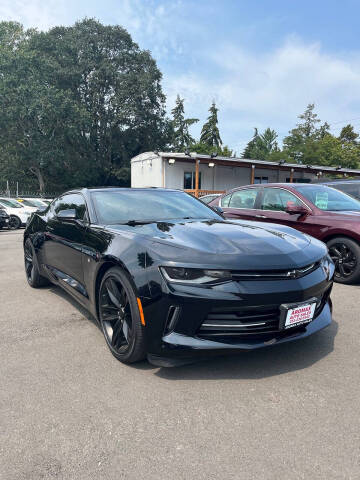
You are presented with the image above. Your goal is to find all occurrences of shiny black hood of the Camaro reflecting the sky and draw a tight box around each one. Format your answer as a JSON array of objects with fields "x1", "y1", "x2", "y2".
[{"x1": 107, "y1": 220, "x2": 326, "y2": 269}]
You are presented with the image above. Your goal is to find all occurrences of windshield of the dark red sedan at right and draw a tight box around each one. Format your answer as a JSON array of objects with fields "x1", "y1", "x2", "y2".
[{"x1": 295, "y1": 185, "x2": 360, "y2": 212}]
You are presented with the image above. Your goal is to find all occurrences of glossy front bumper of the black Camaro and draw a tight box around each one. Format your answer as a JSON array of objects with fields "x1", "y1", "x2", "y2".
[{"x1": 144, "y1": 268, "x2": 333, "y2": 365}]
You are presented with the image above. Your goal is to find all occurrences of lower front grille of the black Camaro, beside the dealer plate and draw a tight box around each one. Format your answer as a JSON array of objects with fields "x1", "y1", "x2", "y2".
[{"x1": 198, "y1": 306, "x2": 280, "y2": 337}]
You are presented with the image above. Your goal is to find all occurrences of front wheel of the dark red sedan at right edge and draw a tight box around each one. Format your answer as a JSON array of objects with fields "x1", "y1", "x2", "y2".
[{"x1": 327, "y1": 237, "x2": 360, "y2": 284}]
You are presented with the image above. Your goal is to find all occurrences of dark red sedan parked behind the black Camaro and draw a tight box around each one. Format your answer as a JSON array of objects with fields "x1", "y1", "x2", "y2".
[{"x1": 210, "y1": 183, "x2": 360, "y2": 283}]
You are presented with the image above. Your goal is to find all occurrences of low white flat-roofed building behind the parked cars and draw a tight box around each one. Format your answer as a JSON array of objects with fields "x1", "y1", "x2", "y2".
[{"x1": 131, "y1": 152, "x2": 360, "y2": 196}]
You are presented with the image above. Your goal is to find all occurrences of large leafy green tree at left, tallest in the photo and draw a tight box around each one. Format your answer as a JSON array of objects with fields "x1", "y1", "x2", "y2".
[{"x1": 0, "y1": 19, "x2": 171, "y2": 190}]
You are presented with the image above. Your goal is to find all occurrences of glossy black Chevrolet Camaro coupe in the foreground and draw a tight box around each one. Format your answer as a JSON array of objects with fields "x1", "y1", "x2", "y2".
[{"x1": 24, "y1": 188, "x2": 334, "y2": 366}]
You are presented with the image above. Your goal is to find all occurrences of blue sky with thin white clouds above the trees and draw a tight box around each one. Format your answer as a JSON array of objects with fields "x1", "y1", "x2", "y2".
[{"x1": 0, "y1": 0, "x2": 360, "y2": 154}]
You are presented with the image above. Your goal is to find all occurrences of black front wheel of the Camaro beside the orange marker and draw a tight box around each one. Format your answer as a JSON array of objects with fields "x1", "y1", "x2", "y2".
[{"x1": 98, "y1": 267, "x2": 146, "y2": 363}]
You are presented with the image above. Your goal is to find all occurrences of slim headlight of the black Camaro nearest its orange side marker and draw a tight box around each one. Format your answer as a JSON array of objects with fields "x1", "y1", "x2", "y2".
[{"x1": 160, "y1": 267, "x2": 231, "y2": 284}]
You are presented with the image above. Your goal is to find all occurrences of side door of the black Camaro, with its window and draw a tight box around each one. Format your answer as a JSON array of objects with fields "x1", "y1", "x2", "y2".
[{"x1": 44, "y1": 193, "x2": 87, "y2": 295}]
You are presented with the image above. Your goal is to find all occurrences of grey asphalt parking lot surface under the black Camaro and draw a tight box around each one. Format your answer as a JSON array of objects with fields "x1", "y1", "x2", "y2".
[{"x1": 0, "y1": 231, "x2": 360, "y2": 480}]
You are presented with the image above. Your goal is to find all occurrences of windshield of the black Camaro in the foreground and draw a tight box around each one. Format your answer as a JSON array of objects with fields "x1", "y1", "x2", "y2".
[{"x1": 91, "y1": 190, "x2": 221, "y2": 225}]
